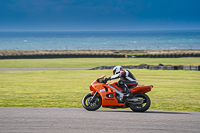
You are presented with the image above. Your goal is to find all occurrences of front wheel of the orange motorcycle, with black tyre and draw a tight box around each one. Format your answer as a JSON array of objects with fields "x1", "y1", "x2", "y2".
[{"x1": 82, "y1": 93, "x2": 102, "y2": 111}]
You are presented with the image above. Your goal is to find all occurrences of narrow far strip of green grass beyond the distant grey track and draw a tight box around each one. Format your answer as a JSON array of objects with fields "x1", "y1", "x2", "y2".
[{"x1": 0, "y1": 57, "x2": 200, "y2": 68}]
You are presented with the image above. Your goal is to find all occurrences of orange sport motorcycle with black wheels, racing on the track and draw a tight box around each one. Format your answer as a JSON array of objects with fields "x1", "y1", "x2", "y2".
[{"x1": 82, "y1": 75, "x2": 153, "y2": 112}]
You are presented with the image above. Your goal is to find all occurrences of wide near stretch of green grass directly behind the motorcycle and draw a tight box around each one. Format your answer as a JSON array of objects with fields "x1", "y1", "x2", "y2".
[{"x1": 0, "y1": 69, "x2": 200, "y2": 112}]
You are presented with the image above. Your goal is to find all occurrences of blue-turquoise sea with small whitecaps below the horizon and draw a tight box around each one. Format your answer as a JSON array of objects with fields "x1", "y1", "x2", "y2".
[{"x1": 0, "y1": 30, "x2": 200, "y2": 50}]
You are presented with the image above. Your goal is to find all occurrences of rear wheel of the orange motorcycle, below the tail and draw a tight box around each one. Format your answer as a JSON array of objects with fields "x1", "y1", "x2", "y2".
[{"x1": 129, "y1": 93, "x2": 151, "y2": 112}]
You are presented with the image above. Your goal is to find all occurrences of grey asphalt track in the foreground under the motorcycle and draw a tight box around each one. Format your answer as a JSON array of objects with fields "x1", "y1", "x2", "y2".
[{"x1": 0, "y1": 107, "x2": 200, "y2": 133}]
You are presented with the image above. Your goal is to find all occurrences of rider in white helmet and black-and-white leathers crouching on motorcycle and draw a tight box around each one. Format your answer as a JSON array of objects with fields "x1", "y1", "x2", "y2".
[{"x1": 104, "y1": 66, "x2": 138, "y2": 97}]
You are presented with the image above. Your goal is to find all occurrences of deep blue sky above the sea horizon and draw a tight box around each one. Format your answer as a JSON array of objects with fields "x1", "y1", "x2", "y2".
[{"x1": 0, "y1": 0, "x2": 200, "y2": 31}]
